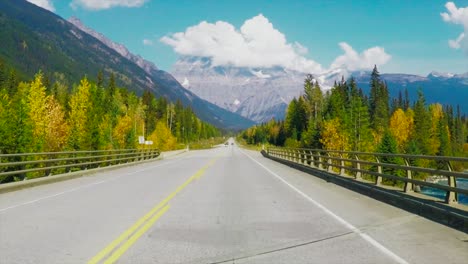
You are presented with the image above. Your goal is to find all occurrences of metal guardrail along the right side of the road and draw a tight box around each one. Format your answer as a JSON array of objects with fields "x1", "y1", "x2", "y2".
[{"x1": 267, "y1": 148, "x2": 468, "y2": 203}]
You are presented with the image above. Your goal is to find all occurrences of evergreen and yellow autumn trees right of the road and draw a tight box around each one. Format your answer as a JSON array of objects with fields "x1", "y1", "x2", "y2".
[{"x1": 240, "y1": 67, "x2": 468, "y2": 156}]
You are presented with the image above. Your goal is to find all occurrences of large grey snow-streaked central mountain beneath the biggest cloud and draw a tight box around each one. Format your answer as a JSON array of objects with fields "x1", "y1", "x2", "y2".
[{"x1": 172, "y1": 57, "x2": 305, "y2": 122}]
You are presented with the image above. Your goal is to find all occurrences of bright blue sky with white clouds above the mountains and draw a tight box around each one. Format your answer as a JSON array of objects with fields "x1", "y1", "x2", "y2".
[{"x1": 30, "y1": 0, "x2": 468, "y2": 75}]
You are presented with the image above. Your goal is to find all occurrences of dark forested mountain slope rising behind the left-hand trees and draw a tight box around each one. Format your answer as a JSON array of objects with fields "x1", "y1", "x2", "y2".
[{"x1": 0, "y1": 0, "x2": 253, "y2": 129}]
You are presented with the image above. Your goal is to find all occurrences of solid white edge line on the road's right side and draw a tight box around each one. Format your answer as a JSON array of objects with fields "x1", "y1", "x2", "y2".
[{"x1": 241, "y1": 150, "x2": 408, "y2": 264}]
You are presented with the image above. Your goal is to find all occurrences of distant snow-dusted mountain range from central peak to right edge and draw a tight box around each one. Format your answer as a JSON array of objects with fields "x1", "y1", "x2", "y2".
[{"x1": 172, "y1": 56, "x2": 468, "y2": 123}]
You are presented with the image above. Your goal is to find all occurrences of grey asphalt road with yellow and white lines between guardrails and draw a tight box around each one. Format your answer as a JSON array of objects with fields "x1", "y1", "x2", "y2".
[{"x1": 0, "y1": 142, "x2": 468, "y2": 263}]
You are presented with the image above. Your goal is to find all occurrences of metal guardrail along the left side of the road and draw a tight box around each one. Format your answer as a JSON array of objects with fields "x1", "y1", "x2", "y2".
[{"x1": 0, "y1": 149, "x2": 160, "y2": 183}]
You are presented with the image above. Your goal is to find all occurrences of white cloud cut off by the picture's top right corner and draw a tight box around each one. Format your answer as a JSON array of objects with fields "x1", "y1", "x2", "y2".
[{"x1": 440, "y1": 2, "x2": 468, "y2": 54}]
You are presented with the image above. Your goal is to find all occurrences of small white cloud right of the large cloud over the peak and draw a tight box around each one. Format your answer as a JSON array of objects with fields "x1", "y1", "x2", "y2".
[{"x1": 331, "y1": 42, "x2": 391, "y2": 71}]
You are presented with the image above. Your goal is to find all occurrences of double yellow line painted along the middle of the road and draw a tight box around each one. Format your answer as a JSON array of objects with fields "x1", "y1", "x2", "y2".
[{"x1": 88, "y1": 158, "x2": 218, "y2": 264}]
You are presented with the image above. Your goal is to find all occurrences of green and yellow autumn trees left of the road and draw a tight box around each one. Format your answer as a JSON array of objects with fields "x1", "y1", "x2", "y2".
[{"x1": 0, "y1": 63, "x2": 220, "y2": 154}]
